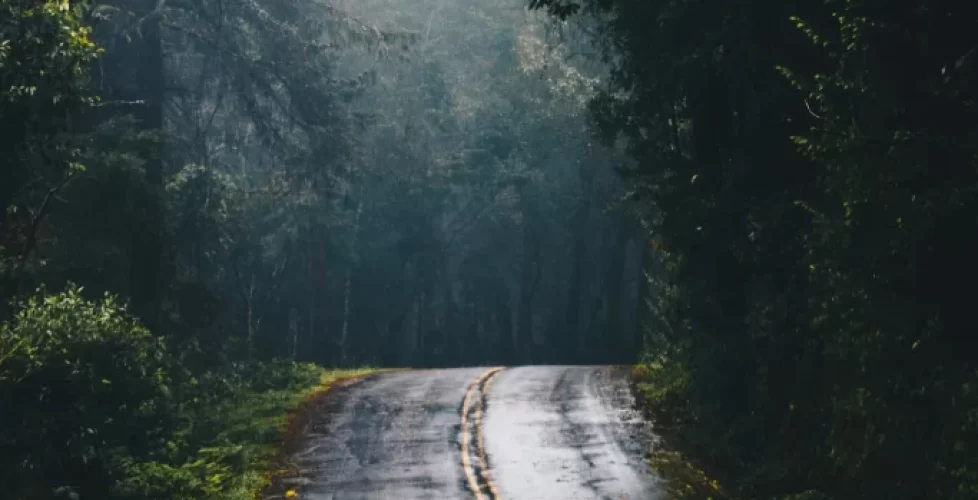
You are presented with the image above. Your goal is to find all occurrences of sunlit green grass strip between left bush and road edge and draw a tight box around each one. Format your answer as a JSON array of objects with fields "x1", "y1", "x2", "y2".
[{"x1": 112, "y1": 362, "x2": 374, "y2": 500}]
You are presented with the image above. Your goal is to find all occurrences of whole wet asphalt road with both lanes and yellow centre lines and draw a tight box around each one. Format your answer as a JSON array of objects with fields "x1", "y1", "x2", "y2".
[{"x1": 286, "y1": 366, "x2": 659, "y2": 500}]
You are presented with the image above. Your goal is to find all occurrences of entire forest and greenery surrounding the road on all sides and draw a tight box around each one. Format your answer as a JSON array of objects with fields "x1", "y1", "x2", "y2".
[{"x1": 0, "y1": 0, "x2": 978, "y2": 500}]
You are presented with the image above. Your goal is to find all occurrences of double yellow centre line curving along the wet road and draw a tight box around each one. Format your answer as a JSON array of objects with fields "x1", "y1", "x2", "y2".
[{"x1": 461, "y1": 367, "x2": 503, "y2": 500}]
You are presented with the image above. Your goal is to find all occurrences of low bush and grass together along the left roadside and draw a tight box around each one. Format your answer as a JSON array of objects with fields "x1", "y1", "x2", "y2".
[{"x1": 0, "y1": 286, "x2": 366, "y2": 500}]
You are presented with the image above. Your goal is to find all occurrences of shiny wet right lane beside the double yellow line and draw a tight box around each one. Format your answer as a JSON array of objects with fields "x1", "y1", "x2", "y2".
[{"x1": 483, "y1": 366, "x2": 661, "y2": 500}]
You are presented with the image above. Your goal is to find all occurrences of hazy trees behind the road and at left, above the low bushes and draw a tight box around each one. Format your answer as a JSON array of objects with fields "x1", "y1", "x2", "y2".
[{"x1": 0, "y1": 0, "x2": 644, "y2": 380}]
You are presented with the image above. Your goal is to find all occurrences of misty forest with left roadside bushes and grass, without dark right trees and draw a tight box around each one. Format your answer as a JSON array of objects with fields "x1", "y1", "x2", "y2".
[{"x1": 0, "y1": 0, "x2": 632, "y2": 498}]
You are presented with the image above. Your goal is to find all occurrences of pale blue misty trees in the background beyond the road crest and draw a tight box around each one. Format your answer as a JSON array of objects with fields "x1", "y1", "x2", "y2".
[{"x1": 152, "y1": 0, "x2": 634, "y2": 366}]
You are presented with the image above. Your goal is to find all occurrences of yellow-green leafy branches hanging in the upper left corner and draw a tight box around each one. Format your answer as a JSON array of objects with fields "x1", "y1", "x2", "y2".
[{"x1": 0, "y1": 0, "x2": 101, "y2": 292}]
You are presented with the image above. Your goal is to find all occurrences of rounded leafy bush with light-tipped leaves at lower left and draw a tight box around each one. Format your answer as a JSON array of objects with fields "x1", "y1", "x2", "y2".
[{"x1": 0, "y1": 286, "x2": 171, "y2": 498}]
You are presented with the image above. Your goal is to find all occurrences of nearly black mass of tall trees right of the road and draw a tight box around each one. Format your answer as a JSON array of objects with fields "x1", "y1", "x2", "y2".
[{"x1": 531, "y1": 0, "x2": 978, "y2": 499}]
